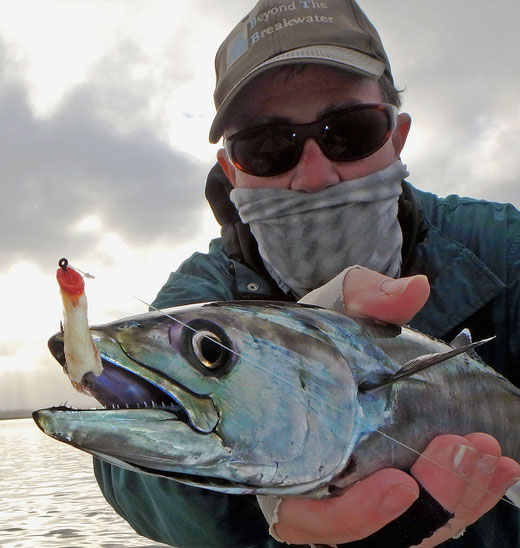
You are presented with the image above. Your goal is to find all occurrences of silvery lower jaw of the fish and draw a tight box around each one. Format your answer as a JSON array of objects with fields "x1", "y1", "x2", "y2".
[{"x1": 32, "y1": 406, "x2": 261, "y2": 494}]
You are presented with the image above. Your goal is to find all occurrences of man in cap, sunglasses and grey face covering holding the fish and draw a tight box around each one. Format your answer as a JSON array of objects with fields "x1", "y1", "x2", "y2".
[{"x1": 95, "y1": 0, "x2": 520, "y2": 548}]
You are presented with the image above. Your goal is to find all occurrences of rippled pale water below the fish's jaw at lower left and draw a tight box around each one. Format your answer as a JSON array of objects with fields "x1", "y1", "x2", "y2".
[{"x1": 0, "y1": 419, "x2": 166, "y2": 548}]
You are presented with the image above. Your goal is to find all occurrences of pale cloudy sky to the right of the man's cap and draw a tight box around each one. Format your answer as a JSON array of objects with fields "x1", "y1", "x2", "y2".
[{"x1": 360, "y1": 0, "x2": 520, "y2": 206}]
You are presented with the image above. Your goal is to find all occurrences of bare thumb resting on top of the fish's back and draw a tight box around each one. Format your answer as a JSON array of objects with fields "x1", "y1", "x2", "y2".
[{"x1": 343, "y1": 268, "x2": 430, "y2": 325}]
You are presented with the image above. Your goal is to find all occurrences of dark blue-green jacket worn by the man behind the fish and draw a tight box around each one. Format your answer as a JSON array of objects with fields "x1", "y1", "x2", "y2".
[{"x1": 94, "y1": 172, "x2": 520, "y2": 548}]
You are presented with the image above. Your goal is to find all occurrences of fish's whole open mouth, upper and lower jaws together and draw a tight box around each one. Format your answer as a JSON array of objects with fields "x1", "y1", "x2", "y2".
[{"x1": 33, "y1": 331, "x2": 250, "y2": 493}]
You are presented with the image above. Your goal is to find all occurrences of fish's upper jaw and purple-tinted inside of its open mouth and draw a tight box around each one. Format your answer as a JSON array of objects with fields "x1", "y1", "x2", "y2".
[{"x1": 42, "y1": 333, "x2": 219, "y2": 434}]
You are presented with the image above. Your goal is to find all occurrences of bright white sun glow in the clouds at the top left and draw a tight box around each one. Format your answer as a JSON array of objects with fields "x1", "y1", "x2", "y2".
[{"x1": 0, "y1": 0, "x2": 193, "y2": 115}]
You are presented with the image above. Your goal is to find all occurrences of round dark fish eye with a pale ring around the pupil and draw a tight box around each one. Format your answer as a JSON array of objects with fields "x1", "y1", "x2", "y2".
[{"x1": 180, "y1": 318, "x2": 236, "y2": 376}]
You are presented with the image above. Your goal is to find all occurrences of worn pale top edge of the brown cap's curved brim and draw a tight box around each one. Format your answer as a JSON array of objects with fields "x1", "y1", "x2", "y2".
[{"x1": 209, "y1": 45, "x2": 385, "y2": 143}]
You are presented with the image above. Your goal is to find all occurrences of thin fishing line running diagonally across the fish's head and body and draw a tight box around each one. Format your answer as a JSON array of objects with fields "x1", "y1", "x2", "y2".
[{"x1": 135, "y1": 297, "x2": 520, "y2": 509}]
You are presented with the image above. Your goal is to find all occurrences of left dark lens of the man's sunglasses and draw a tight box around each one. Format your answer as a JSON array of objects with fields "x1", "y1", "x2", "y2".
[{"x1": 232, "y1": 127, "x2": 298, "y2": 177}]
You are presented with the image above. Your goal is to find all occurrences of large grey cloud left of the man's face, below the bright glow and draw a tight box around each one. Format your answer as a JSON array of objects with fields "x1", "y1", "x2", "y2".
[{"x1": 0, "y1": 35, "x2": 214, "y2": 267}]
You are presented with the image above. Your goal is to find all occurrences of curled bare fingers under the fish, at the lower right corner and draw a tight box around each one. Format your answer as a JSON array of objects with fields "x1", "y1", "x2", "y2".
[{"x1": 412, "y1": 433, "x2": 520, "y2": 548}]
